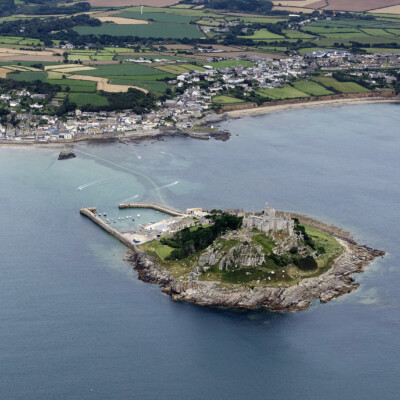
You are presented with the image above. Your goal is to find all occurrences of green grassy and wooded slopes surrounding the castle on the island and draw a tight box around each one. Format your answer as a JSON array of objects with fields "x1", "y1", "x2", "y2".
[{"x1": 139, "y1": 214, "x2": 343, "y2": 287}]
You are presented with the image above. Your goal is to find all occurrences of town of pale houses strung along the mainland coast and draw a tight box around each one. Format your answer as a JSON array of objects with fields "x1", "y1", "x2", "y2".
[{"x1": 0, "y1": 50, "x2": 400, "y2": 143}]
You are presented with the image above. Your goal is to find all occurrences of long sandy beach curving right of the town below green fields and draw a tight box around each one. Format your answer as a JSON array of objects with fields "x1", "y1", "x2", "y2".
[{"x1": 223, "y1": 97, "x2": 400, "y2": 119}]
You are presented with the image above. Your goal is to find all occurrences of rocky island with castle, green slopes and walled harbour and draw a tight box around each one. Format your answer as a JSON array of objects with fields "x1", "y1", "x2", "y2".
[{"x1": 81, "y1": 203, "x2": 385, "y2": 311}]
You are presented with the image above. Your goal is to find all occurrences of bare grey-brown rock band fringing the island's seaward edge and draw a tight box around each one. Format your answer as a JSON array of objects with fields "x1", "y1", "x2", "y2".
[{"x1": 128, "y1": 214, "x2": 385, "y2": 312}]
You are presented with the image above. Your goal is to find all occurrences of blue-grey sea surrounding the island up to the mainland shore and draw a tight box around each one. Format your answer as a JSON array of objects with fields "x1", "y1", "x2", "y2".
[{"x1": 0, "y1": 104, "x2": 400, "y2": 400}]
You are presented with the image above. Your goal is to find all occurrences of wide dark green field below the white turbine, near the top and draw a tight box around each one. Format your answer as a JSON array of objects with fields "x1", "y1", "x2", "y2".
[{"x1": 74, "y1": 22, "x2": 204, "y2": 39}]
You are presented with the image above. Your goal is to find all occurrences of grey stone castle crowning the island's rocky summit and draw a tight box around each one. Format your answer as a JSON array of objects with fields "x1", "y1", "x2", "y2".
[{"x1": 243, "y1": 203, "x2": 294, "y2": 236}]
